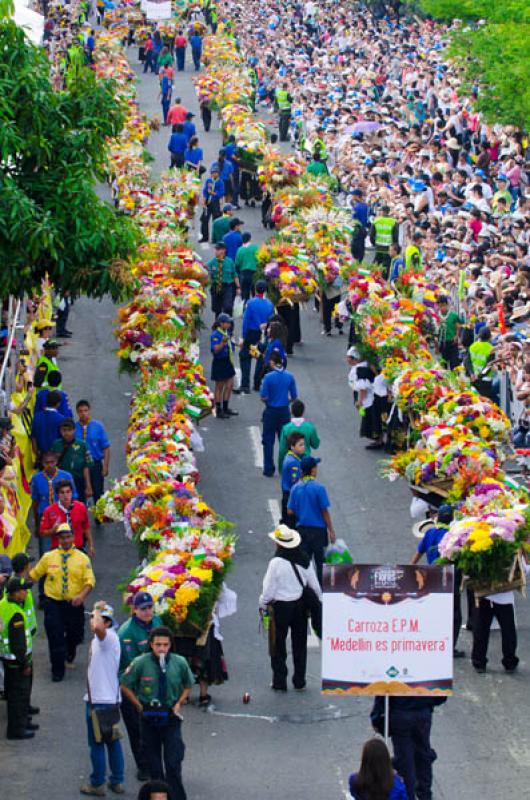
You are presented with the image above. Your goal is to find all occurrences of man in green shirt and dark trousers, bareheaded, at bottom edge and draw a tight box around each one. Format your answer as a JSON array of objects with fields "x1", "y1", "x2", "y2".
[{"x1": 122, "y1": 627, "x2": 195, "y2": 800}]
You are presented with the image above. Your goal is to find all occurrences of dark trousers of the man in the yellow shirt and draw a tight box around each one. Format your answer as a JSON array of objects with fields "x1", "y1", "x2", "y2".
[{"x1": 44, "y1": 597, "x2": 85, "y2": 678}]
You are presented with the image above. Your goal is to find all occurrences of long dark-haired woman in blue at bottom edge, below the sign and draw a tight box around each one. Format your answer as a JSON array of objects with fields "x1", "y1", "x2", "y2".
[{"x1": 349, "y1": 738, "x2": 408, "y2": 800}]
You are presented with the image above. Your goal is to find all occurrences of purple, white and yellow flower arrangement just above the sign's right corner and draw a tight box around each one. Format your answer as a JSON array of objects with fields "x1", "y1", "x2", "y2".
[{"x1": 439, "y1": 509, "x2": 530, "y2": 593}]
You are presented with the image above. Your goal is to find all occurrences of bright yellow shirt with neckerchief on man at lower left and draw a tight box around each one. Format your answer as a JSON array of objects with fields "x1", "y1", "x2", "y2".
[{"x1": 30, "y1": 547, "x2": 96, "y2": 600}]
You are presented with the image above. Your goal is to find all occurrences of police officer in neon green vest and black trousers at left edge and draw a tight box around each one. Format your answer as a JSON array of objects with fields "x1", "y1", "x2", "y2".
[{"x1": 0, "y1": 576, "x2": 39, "y2": 739}]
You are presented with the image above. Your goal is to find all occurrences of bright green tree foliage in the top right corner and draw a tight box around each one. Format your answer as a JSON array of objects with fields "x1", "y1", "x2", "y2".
[{"x1": 420, "y1": 0, "x2": 530, "y2": 128}]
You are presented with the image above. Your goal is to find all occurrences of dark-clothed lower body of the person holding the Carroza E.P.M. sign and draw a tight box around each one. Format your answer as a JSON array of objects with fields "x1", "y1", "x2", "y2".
[{"x1": 370, "y1": 697, "x2": 447, "y2": 800}]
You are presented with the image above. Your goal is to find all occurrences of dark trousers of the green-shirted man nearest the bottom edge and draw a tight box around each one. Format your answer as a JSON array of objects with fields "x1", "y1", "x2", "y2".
[{"x1": 142, "y1": 719, "x2": 186, "y2": 800}]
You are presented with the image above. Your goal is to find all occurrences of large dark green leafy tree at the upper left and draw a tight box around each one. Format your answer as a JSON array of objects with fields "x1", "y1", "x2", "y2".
[{"x1": 0, "y1": 20, "x2": 139, "y2": 299}]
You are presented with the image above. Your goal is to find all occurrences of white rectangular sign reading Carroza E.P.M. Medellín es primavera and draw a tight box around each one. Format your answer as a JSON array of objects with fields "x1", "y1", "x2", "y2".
[{"x1": 322, "y1": 564, "x2": 453, "y2": 695}]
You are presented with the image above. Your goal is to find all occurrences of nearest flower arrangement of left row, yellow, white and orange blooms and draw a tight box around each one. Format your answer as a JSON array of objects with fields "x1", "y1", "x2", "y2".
[{"x1": 125, "y1": 532, "x2": 234, "y2": 636}]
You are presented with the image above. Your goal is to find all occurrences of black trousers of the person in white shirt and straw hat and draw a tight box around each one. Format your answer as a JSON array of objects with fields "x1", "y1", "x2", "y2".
[{"x1": 270, "y1": 600, "x2": 307, "y2": 689}]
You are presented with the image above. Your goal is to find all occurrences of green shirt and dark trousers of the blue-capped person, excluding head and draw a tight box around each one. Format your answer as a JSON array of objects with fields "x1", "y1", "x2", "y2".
[{"x1": 118, "y1": 614, "x2": 162, "y2": 774}]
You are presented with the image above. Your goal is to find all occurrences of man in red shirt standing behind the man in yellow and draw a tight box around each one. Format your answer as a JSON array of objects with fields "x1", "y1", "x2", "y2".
[{"x1": 39, "y1": 480, "x2": 95, "y2": 558}]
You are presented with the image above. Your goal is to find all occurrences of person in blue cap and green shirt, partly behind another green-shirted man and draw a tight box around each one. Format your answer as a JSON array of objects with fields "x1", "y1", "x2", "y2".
[{"x1": 118, "y1": 592, "x2": 162, "y2": 781}]
